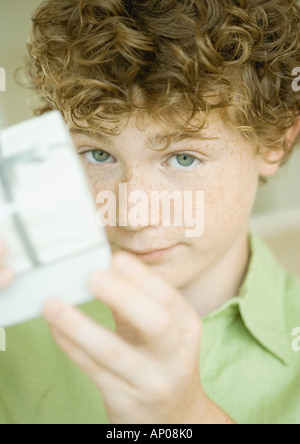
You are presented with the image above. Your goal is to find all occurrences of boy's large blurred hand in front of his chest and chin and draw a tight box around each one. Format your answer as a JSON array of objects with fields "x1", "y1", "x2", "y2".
[{"x1": 44, "y1": 253, "x2": 232, "y2": 424}]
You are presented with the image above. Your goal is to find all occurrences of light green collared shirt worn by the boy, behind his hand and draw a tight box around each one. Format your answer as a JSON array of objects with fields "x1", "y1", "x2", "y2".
[{"x1": 0, "y1": 234, "x2": 300, "y2": 424}]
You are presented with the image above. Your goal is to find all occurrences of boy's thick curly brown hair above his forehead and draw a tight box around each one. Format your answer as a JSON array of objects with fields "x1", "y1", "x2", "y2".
[{"x1": 27, "y1": 0, "x2": 300, "y2": 163}]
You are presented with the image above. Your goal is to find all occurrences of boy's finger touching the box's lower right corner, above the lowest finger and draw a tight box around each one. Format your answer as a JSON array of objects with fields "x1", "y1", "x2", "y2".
[{"x1": 89, "y1": 272, "x2": 178, "y2": 349}]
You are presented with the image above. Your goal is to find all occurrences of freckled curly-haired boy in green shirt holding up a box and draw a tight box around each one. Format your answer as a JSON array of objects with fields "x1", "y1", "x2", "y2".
[{"x1": 0, "y1": 0, "x2": 300, "y2": 424}]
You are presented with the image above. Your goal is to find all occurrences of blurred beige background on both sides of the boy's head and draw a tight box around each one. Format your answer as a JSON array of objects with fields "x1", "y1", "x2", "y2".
[{"x1": 0, "y1": 0, "x2": 300, "y2": 273}]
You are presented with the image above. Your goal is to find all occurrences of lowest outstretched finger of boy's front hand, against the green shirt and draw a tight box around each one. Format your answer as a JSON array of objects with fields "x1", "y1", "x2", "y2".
[{"x1": 44, "y1": 299, "x2": 149, "y2": 385}]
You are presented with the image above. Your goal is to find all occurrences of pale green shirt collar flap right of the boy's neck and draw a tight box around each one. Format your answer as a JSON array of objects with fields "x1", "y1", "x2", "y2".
[{"x1": 204, "y1": 233, "x2": 290, "y2": 364}]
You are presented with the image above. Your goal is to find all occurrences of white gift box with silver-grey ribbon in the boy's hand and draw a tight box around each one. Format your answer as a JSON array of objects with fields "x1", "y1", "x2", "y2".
[{"x1": 0, "y1": 112, "x2": 111, "y2": 327}]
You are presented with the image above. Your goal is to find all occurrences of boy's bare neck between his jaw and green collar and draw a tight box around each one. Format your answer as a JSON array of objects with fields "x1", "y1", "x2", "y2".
[{"x1": 180, "y1": 227, "x2": 251, "y2": 318}]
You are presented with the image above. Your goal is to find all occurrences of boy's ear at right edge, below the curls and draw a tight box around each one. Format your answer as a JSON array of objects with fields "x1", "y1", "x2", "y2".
[{"x1": 259, "y1": 116, "x2": 300, "y2": 177}]
